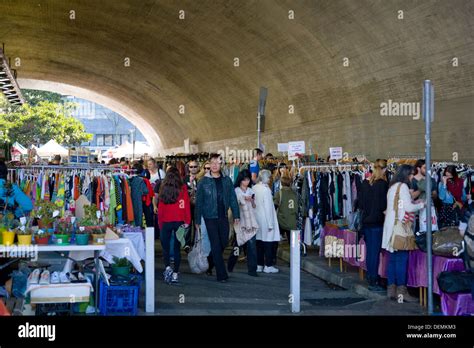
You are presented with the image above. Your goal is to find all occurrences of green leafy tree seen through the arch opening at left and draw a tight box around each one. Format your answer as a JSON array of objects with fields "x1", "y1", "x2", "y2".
[{"x1": 0, "y1": 94, "x2": 92, "y2": 146}]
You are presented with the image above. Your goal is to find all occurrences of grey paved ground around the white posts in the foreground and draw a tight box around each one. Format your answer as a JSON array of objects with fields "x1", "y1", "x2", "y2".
[{"x1": 140, "y1": 243, "x2": 424, "y2": 315}]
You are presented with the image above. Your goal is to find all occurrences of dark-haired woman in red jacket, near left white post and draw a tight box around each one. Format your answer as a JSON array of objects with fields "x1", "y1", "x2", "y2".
[{"x1": 158, "y1": 167, "x2": 191, "y2": 283}]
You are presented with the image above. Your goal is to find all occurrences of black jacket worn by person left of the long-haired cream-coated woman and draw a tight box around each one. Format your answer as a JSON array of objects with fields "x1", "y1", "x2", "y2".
[{"x1": 359, "y1": 180, "x2": 388, "y2": 227}]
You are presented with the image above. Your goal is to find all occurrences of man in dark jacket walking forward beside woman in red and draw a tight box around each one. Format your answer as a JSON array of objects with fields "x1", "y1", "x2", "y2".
[{"x1": 194, "y1": 154, "x2": 240, "y2": 283}]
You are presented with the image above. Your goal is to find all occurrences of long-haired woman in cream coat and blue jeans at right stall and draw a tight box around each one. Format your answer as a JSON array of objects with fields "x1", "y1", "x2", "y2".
[{"x1": 382, "y1": 164, "x2": 425, "y2": 302}]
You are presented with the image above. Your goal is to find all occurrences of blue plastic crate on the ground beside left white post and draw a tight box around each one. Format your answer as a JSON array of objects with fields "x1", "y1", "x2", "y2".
[{"x1": 99, "y1": 279, "x2": 139, "y2": 315}]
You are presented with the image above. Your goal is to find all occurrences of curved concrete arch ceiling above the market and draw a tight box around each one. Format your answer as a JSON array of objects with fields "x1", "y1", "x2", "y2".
[{"x1": 0, "y1": 0, "x2": 474, "y2": 156}]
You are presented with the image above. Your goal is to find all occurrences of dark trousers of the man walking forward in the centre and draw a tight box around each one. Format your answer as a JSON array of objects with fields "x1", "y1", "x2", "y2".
[{"x1": 204, "y1": 217, "x2": 229, "y2": 280}]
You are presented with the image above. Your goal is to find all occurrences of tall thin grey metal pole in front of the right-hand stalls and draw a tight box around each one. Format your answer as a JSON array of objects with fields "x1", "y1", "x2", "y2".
[{"x1": 423, "y1": 80, "x2": 434, "y2": 315}]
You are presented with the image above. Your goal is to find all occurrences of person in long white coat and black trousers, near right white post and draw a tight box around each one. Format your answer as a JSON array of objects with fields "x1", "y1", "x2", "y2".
[{"x1": 253, "y1": 169, "x2": 280, "y2": 273}]
